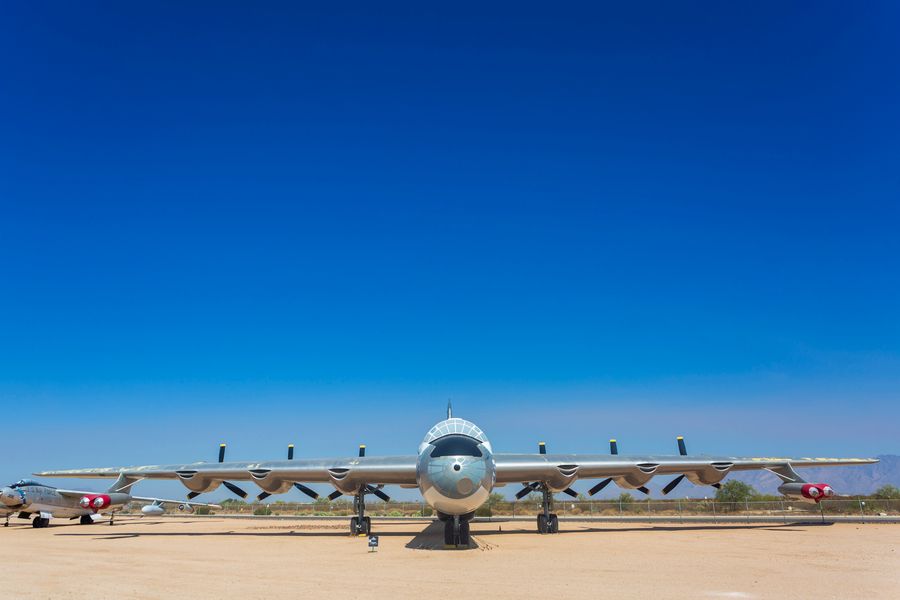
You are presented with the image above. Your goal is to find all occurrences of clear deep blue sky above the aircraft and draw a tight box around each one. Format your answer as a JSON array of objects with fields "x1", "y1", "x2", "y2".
[{"x1": 0, "y1": 2, "x2": 900, "y2": 494}]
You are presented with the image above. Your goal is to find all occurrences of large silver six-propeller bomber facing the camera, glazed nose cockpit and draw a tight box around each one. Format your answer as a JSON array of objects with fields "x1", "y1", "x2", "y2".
[{"x1": 36, "y1": 406, "x2": 877, "y2": 546}]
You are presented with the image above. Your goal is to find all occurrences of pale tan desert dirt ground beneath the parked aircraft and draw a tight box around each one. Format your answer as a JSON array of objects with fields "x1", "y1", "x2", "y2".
[{"x1": 0, "y1": 517, "x2": 900, "y2": 599}]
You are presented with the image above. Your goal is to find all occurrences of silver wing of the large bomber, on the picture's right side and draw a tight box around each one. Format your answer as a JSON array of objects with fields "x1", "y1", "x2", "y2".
[{"x1": 494, "y1": 454, "x2": 878, "y2": 489}]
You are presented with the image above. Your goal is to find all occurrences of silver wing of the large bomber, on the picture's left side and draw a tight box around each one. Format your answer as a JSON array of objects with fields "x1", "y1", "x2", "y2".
[{"x1": 36, "y1": 456, "x2": 416, "y2": 494}]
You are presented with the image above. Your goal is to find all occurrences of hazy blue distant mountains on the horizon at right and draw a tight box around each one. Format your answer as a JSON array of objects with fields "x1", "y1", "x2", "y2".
[{"x1": 597, "y1": 454, "x2": 900, "y2": 499}]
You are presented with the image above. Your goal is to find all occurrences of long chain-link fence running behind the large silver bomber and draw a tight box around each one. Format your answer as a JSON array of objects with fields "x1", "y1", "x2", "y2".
[{"x1": 126, "y1": 498, "x2": 900, "y2": 521}]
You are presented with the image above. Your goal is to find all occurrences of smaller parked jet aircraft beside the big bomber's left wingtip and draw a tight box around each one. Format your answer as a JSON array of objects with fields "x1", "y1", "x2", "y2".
[{"x1": 0, "y1": 477, "x2": 221, "y2": 527}]
